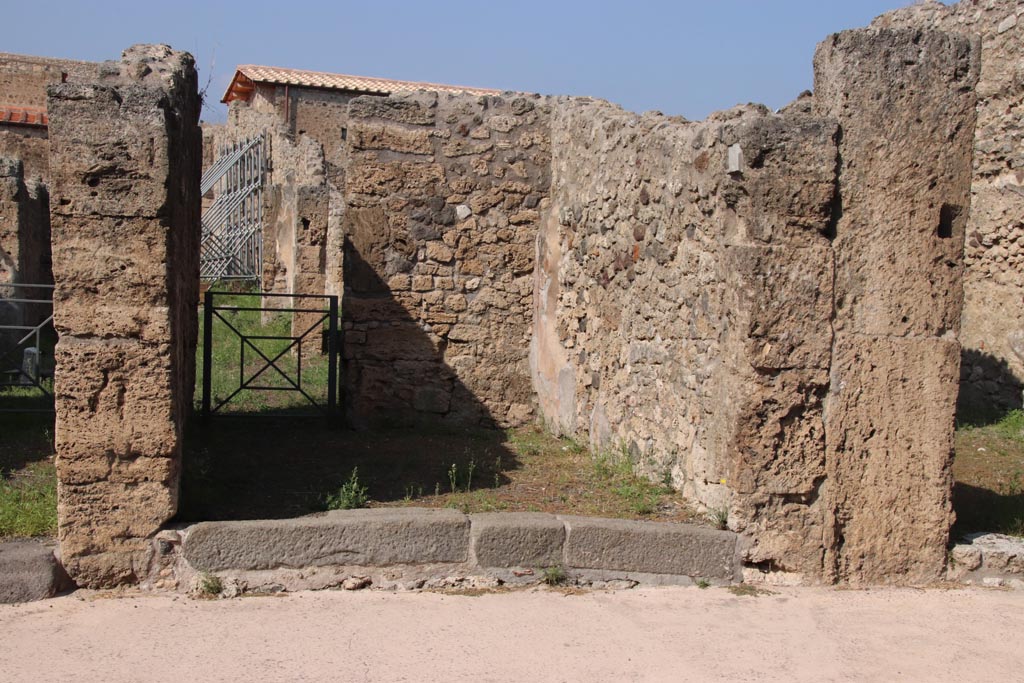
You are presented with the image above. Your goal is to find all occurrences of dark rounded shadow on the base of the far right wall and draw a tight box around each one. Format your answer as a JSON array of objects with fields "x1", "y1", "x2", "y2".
[{"x1": 956, "y1": 348, "x2": 1024, "y2": 427}]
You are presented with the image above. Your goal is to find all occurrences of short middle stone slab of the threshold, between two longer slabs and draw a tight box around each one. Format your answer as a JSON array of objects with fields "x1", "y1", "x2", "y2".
[{"x1": 470, "y1": 512, "x2": 565, "y2": 568}]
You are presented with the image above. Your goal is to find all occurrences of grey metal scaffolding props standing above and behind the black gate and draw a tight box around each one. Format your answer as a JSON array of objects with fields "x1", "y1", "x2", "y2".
[{"x1": 200, "y1": 135, "x2": 266, "y2": 281}]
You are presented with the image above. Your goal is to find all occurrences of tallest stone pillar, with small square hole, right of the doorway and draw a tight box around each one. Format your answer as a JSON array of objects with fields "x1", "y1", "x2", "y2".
[{"x1": 814, "y1": 30, "x2": 978, "y2": 583}]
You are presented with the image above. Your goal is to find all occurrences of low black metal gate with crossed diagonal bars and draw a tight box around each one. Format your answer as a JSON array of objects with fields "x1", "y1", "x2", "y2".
[{"x1": 202, "y1": 290, "x2": 339, "y2": 421}]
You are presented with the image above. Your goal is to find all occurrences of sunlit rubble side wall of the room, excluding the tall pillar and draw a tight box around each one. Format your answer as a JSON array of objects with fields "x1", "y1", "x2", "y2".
[{"x1": 531, "y1": 99, "x2": 836, "y2": 575}]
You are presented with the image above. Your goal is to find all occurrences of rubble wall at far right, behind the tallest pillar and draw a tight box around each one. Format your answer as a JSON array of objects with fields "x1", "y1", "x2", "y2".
[{"x1": 874, "y1": 0, "x2": 1024, "y2": 419}]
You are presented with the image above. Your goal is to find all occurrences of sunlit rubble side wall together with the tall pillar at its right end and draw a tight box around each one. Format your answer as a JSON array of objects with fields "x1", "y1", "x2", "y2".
[{"x1": 531, "y1": 26, "x2": 977, "y2": 582}]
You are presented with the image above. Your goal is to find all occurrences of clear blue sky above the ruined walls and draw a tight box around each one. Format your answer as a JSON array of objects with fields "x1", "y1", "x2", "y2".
[{"x1": 0, "y1": 0, "x2": 912, "y2": 121}]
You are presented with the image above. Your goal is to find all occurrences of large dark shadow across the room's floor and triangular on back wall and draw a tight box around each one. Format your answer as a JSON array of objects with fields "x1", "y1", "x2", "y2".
[{"x1": 177, "y1": 248, "x2": 520, "y2": 521}]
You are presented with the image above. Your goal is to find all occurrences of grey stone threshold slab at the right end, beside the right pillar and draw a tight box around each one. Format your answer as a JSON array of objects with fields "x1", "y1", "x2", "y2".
[{"x1": 559, "y1": 516, "x2": 737, "y2": 579}]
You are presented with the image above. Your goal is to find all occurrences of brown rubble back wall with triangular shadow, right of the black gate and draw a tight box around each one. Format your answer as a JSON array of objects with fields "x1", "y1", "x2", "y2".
[{"x1": 341, "y1": 93, "x2": 551, "y2": 425}]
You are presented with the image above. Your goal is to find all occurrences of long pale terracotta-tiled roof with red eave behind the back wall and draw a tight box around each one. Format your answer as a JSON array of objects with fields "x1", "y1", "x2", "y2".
[{"x1": 221, "y1": 65, "x2": 501, "y2": 102}]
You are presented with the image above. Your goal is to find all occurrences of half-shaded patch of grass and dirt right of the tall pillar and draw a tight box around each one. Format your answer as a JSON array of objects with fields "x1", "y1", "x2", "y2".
[{"x1": 953, "y1": 411, "x2": 1024, "y2": 538}]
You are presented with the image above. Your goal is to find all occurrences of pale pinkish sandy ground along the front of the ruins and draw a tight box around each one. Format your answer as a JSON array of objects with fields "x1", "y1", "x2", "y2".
[{"x1": 0, "y1": 588, "x2": 1024, "y2": 683}]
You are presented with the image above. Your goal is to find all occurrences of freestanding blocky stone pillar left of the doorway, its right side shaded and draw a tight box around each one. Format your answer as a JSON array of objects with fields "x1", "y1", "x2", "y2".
[{"x1": 48, "y1": 45, "x2": 202, "y2": 587}]
